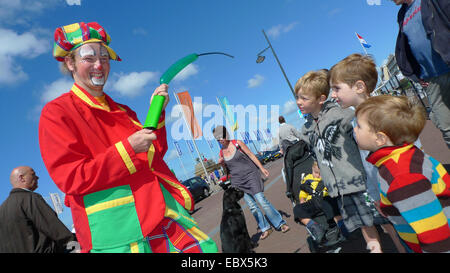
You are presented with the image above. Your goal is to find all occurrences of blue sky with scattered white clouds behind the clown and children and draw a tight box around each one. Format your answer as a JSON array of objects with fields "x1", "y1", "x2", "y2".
[{"x1": 0, "y1": 0, "x2": 398, "y2": 226}]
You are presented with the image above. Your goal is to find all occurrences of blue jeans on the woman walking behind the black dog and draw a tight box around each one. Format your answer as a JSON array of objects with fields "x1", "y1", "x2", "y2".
[{"x1": 244, "y1": 192, "x2": 286, "y2": 232}]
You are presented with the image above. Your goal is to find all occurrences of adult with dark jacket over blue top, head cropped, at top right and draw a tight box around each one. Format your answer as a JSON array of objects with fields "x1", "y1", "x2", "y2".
[{"x1": 393, "y1": 0, "x2": 450, "y2": 149}]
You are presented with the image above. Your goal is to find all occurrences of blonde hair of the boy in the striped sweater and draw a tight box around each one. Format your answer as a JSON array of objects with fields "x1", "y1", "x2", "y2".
[{"x1": 355, "y1": 95, "x2": 426, "y2": 145}]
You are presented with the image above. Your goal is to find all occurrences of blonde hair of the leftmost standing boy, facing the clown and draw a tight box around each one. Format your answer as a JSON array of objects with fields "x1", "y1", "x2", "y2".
[{"x1": 294, "y1": 69, "x2": 330, "y2": 98}]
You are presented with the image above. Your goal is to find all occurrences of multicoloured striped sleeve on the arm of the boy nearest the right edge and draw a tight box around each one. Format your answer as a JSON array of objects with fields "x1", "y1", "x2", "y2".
[{"x1": 383, "y1": 173, "x2": 450, "y2": 252}]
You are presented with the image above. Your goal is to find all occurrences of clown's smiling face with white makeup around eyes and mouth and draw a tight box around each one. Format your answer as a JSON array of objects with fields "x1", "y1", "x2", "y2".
[{"x1": 73, "y1": 43, "x2": 110, "y2": 96}]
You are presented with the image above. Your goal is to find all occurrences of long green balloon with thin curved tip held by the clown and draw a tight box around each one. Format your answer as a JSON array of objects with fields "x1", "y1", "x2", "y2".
[{"x1": 144, "y1": 52, "x2": 233, "y2": 130}]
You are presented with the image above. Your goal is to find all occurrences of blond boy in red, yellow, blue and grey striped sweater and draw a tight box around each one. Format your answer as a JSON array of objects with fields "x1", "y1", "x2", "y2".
[{"x1": 354, "y1": 95, "x2": 450, "y2": 252}]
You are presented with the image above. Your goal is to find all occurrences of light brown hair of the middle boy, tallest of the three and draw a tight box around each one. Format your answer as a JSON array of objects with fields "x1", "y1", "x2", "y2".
[{"x1": 330, "y1": 53, "x2": 378, "y2": 95}]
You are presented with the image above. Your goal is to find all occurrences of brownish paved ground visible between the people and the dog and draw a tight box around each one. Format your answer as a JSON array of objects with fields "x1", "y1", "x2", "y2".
[{"x1": 193, "y1": 121, "x2": 450, "y2": 253}]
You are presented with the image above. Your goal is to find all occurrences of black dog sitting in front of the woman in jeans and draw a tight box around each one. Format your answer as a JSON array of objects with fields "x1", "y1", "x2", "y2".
[{"x1": 220, "y1": 187, "x2": 257, "y2": 253}]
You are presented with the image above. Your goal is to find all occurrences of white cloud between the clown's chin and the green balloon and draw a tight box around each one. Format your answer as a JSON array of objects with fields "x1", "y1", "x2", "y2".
[{"x1": 111, "y1": 71, "x2": 158, "y2": 97}]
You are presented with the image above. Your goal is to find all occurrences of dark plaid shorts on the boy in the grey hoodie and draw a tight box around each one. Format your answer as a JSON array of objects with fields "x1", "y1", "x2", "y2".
[{"x1": 336, "y1": 191, "x2": 389, "y2": 232}]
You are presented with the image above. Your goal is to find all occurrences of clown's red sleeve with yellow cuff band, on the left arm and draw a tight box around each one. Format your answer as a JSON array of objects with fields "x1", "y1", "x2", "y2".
[{"x1": 39, "y1": 103, "x2": 143, "y2": 195}]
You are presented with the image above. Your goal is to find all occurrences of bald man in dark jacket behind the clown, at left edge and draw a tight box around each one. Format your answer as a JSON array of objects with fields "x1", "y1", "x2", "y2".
[{"x1": 0, "y1": 166, "x2": 75, "y2": 253}]
